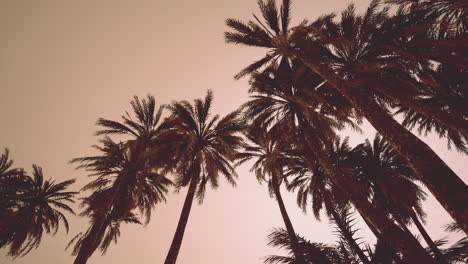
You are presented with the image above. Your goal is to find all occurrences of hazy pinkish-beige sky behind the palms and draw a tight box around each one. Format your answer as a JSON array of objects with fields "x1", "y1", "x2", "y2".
[{"x1": 0, "y1": 0, "x2": 468, "y2": 264}]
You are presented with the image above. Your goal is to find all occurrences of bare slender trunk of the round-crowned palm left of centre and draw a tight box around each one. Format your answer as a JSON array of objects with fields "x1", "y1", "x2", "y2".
[{"x1": 164, "y1": 176, "x2": 198, "y2": 264}]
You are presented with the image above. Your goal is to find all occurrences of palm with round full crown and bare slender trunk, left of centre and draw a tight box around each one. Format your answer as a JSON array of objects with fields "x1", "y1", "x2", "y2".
[{"x1": 164, "y1": 91, "x2": 243, "y2": 264}]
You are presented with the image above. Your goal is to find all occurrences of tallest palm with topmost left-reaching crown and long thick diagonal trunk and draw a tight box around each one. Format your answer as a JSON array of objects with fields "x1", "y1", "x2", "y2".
[{"x1": 226, "y1": 0, "x2": 468, "y2": 235}]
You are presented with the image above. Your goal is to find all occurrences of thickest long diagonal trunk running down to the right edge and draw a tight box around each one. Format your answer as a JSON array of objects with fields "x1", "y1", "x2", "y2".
[{"x1": 291, "y1": 47, "x2": 468, "y2": 233}]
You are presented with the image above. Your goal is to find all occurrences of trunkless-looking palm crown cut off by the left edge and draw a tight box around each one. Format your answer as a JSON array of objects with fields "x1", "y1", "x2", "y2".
[{"x1": 0, "y1": 165, "x2": 77, "y2": 258}]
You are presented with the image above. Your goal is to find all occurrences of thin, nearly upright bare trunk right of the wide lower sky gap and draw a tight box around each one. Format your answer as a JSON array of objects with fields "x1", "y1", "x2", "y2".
[{"x1": 271, "y1": 175, "x2": 305, "y2": 264}]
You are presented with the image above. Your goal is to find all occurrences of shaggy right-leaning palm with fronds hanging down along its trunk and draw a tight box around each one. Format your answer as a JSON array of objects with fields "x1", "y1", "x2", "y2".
[{"x1": 70, "y1": 95, "x2": 171, "y2": 264}]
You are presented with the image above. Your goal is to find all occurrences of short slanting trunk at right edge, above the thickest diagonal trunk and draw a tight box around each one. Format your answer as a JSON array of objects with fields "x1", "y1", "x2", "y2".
[{"x1": 373, "y1": 78, "x2": 468, "y2": 137}]
